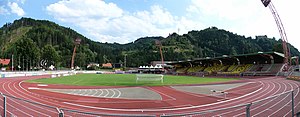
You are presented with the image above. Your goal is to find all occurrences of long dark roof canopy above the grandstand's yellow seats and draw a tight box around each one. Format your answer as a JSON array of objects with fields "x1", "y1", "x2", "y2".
[{"x1": 166, "y1": 52, "x2": 284, "y2": 66}]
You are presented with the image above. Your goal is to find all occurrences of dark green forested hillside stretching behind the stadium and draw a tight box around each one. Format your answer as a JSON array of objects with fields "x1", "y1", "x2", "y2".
[{"x1": 0, "y1": 18, "x2": 300, "y2": 68}]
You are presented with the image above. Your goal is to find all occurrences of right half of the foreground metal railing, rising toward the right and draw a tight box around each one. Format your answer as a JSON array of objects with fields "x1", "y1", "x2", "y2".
[{"x1": 160, "y1": 87, "x2": 300, "y2": 117}]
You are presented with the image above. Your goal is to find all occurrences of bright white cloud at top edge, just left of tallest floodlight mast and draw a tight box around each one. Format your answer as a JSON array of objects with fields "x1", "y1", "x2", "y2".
[{"x1": 187, "y1": 0, "x2": 259, "y2": 20}]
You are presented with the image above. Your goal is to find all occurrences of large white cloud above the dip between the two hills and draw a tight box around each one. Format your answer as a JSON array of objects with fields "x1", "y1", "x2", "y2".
[{"x1": 47, "y1": 0, "x2": 196, "y2": 43}]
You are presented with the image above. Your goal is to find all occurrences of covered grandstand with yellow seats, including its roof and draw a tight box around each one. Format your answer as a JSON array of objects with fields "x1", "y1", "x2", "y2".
[{"x1": 167, "y1": 52, "x2": 284, "y2": 76}]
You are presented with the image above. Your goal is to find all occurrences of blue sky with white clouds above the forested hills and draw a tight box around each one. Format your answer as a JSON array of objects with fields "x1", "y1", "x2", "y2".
[{"x1": 0, "y1": 0, "x2": 300, "y2": 49}]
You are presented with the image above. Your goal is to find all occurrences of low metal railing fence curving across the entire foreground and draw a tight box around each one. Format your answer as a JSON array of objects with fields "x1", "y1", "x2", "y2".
[{"x1": 0, "y1": 87, "x2": 300, "y2": 117}]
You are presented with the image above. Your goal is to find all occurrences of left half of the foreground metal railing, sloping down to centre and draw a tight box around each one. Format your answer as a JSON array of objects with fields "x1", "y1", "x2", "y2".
[{"x1": 0, "y1": 93, "x2": 155, "y2": 117}]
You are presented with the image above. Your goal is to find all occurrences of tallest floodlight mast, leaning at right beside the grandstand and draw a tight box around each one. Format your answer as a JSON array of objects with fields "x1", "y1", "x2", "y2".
[{"x1": 261, "y1": 0, "x2": 290, "y2": 70}]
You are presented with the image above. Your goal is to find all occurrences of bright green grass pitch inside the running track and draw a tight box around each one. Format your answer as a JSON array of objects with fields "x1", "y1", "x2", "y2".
[{"x1": 26, "y1": 74, "x2": 239, "y2": 86}]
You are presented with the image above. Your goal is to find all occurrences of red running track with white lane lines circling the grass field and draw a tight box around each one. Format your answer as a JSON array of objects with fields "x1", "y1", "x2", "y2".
[{"x1": 0, "y1": 76, "x2": 300, "y2": 117}]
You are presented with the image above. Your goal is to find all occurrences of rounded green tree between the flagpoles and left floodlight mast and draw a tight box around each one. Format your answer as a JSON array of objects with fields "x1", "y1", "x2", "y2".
[{"x1": 41, "y1": 44, "x2": 59, "y2": 67}]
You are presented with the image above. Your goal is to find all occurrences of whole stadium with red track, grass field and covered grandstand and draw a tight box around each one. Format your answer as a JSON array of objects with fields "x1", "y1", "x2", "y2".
[{"x1": 1, "y1": 52, "x2": 300, "y2": 116}]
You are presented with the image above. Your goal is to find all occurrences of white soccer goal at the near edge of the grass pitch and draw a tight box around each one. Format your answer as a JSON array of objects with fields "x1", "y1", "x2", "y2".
[{"x1": 136, "y1": 74, "x2": 164, "y2": 83}]
